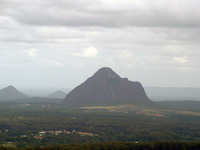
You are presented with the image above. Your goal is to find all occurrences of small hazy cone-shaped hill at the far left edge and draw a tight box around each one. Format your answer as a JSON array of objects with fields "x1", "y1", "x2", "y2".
[{"x1": 0, "y1": 86, "x2": 28, "y2": 100}]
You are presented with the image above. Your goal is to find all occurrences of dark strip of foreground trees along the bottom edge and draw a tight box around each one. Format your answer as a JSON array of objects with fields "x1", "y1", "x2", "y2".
[{"x1": 0, "y1": 142, "x2": 200, "y2": 150}]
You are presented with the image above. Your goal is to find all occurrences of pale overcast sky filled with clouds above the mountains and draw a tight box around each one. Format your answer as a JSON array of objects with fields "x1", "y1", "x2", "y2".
[{"x1": 0, "y1": 0, "x2": 200, "y2": 88}]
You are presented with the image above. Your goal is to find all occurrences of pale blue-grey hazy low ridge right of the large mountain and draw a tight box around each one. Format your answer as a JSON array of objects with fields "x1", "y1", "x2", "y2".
[{"x1": 144, "y1": 87, "x2": 200, "y2": 101}]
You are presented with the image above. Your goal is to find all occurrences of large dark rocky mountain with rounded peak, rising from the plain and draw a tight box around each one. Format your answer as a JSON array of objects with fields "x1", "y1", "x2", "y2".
[{"x1": 63, "y1": 67, "x2": 150, "y2": 104}]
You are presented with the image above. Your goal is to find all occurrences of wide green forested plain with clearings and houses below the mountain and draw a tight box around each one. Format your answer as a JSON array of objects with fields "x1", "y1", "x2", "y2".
[{"x1": 0, "y1": 102, "x2": 200, "y2": 149}]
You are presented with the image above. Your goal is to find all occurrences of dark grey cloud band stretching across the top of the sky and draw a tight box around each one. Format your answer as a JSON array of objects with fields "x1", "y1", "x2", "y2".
[{"x1": 3, "y1": 0, "x2": 200, "y2": 27}]
